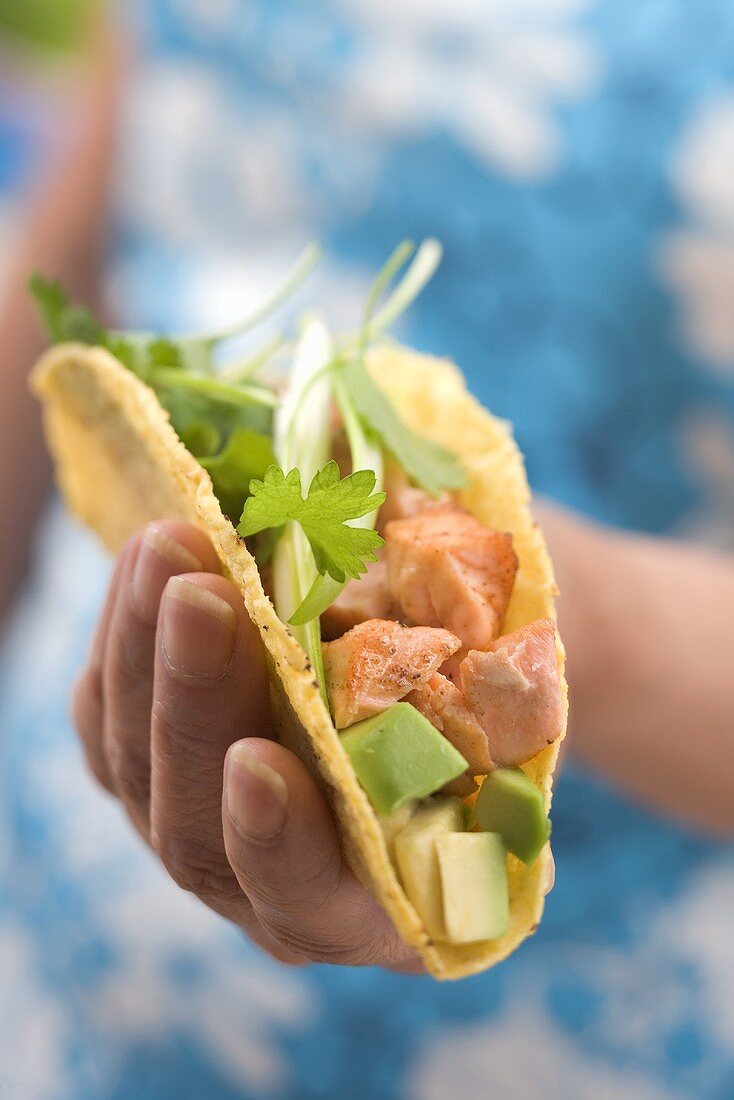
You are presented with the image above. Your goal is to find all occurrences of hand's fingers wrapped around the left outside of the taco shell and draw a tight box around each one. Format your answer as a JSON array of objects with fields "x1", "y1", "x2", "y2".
[{"x1": 74, "y1": 520, "x2": 419, "y2": 969}]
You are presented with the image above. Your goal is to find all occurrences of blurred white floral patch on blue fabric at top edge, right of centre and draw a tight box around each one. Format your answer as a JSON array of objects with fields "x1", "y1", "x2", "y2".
[{"x1": 341, "y1": 0, "x2": 601, "y2": 180}]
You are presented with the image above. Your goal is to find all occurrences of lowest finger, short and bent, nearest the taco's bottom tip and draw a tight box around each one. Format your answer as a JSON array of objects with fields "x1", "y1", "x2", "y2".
[{"x1": 222, "y1": 738, "x2": 413, "y2": 966}]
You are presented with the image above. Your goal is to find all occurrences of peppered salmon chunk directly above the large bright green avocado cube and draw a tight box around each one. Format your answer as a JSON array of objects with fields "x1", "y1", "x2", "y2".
[{"x1": 324, "y1": 619, "x2": 461, "y2": 729}]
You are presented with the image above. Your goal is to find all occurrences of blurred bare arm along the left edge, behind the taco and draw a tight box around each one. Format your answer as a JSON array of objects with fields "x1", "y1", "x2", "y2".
[{"x1": 0, "y1": 25, "x2": 118, "y2": 618}]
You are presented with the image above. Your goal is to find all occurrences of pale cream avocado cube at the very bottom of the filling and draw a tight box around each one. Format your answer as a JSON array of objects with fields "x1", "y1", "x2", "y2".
[{"x1": 435, "y1": 833, "x2": 510, "y2": 944}]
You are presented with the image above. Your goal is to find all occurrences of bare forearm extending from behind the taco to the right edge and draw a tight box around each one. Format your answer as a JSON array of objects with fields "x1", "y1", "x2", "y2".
[{"x1": 539, "y1": 506, "x2": 734, "y2": 834}]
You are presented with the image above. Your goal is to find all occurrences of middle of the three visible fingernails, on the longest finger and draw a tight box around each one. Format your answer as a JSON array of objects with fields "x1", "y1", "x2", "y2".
[{"x1": 161, "y1": 576, "x2": 237, "y2": 680}]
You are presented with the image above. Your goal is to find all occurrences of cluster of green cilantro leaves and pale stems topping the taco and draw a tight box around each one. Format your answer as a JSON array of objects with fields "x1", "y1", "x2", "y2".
[{"x1": 30, "y1": 240, "x2": 467, "y2": 651}]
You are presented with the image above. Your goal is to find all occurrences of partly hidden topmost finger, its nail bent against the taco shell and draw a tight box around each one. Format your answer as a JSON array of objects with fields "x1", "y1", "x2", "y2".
[{"x1": 103, "y1": 520, "x2": 219, "y2": 836}]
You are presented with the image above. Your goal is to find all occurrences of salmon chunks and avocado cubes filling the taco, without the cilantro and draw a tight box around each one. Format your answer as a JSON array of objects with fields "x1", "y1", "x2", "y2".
[{"x1": 322, "y1": 471, "x2": 563, "y2": 944}]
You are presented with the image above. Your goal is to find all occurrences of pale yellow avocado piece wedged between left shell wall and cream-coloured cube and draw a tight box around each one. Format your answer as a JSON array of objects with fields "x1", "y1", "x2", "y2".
[{"x1": 394, "y1": 799, "x2": 463, "y2": 939}]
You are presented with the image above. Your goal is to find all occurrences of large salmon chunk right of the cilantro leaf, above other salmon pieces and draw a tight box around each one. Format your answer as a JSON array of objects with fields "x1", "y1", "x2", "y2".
[{"x1": 385, "y1": 507, "x2": 517, "y2": 649}]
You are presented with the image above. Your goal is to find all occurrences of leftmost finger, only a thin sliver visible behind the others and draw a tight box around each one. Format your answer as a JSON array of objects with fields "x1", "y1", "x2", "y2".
[{"x1": 72, "y1": 540, "x2": 134, "y2": 793}]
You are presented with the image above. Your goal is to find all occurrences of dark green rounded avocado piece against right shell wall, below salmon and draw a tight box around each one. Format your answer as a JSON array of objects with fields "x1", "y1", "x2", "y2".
[{"x1": 474, "y1": 768, "x2": 550, "y2": 866}]
